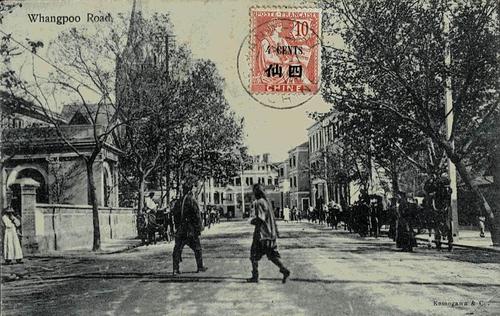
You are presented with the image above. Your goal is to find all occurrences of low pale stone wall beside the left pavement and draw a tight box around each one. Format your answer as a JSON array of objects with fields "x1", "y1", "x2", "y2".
[{"x1": 28, "y1": 204, "x2": 137, "y2": 253}]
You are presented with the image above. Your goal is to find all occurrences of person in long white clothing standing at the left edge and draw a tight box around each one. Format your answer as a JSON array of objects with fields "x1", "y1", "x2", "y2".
[{"x1": 2, "y1": 206, "x2": 23, "y2": 264}]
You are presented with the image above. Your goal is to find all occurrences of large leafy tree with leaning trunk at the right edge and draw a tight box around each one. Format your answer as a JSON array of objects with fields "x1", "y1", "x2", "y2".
[{"x1": 323, "y1": 0, "x2": 500, "y2": 245}]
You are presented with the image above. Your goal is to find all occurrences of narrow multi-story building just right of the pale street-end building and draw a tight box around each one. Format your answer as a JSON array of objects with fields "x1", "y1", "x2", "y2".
[{"x1": 288, "y1": 142, "x2": 310, "y2": 211}]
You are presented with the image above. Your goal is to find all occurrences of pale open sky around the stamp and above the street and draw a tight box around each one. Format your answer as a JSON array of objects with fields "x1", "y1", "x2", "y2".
[{"x1": 0, "y1": 0, "x2": 330, "y2": 161}]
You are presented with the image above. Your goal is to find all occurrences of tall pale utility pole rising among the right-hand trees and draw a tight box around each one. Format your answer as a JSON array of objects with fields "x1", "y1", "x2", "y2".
[{"x1": 443, "y1": 7, "x2": 458, "y2": 239}]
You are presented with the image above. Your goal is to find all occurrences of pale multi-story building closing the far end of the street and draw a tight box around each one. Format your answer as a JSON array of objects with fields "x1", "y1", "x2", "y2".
[{"x1": 198, "y1": 153, "x2": 282, "y2": 218}]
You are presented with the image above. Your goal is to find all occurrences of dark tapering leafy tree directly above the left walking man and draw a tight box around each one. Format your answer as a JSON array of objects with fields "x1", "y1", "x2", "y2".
[{"x1": 172, "y1": 60, "x2": 243, "y2": 200}]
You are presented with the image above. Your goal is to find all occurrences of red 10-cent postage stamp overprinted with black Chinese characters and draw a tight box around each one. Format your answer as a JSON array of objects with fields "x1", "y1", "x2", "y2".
[{"x1": 250, "y1": 7, "x2": 321, "y2": 94}]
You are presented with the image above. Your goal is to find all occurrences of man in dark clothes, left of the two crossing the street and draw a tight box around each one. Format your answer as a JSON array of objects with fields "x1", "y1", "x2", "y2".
[{"x1": 172, "y1": 182, "x2": 207, "y2": 275}]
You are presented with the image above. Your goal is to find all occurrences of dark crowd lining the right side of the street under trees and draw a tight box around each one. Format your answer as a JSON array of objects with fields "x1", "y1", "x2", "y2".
[{"x1": 275, "y1": 177, "x2": 466, "y2": 251}]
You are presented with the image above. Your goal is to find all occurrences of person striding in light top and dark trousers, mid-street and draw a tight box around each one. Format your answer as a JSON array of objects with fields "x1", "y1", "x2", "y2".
[{"x1": 247, "y1": 184, "x2": 290, "y2": 283}]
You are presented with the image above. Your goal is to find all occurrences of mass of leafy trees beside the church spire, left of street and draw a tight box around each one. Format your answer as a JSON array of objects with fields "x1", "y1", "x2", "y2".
[{"x1": 115, "y1": 14, "x2": 245, "y2": 211}]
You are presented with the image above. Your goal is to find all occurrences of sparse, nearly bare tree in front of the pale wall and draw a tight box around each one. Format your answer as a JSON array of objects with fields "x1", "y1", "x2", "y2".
[{"x1": 9, "y1": 12, "x2": 135, "y2": 250}]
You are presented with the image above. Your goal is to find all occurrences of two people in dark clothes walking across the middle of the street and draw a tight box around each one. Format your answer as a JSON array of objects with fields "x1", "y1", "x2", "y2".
[{"x1": 172, "y1": 183, "x2": 290, "y2": 283}]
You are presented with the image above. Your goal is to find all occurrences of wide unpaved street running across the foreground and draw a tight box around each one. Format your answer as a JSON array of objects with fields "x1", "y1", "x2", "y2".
[{"x1": 2, "y1": 221, "x2": 500, "y2": 316}]
